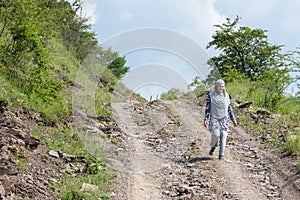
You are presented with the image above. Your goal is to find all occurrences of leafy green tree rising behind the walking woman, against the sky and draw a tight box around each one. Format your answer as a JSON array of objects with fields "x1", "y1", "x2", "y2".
[{"x1": 207, "y1": 16, "x2": 291, "y2": 109}]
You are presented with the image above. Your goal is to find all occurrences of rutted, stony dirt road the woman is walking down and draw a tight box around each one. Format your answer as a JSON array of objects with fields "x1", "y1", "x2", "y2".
[{"x1": 112, "y1": 100, "x2": 300, "y2": 200}]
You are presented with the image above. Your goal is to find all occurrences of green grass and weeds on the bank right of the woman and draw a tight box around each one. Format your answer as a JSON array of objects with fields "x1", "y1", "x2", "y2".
[{"x1": 227, "y1": 80, "x2": 300, "y2": 159}]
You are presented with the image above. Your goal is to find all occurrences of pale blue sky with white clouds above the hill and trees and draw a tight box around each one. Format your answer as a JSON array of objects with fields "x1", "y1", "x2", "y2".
[{"x1": 76, "y1": 0, "x2": 300, "y2": 98}]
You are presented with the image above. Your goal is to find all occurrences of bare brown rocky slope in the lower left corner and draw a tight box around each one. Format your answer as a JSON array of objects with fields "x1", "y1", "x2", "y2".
[{"x1": 0, "y1": 102, "x2": 86, "y2": 200}]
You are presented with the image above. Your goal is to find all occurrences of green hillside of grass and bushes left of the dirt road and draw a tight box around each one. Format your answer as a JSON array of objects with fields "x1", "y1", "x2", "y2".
[{"x1": 0, "y1": 0, "x2": 128, "y2": 199}]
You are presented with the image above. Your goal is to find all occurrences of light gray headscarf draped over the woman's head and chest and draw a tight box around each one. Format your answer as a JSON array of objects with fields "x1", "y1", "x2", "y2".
[{"x1": 210, "y1": 80, "x2": 230, "y2": 119}]
